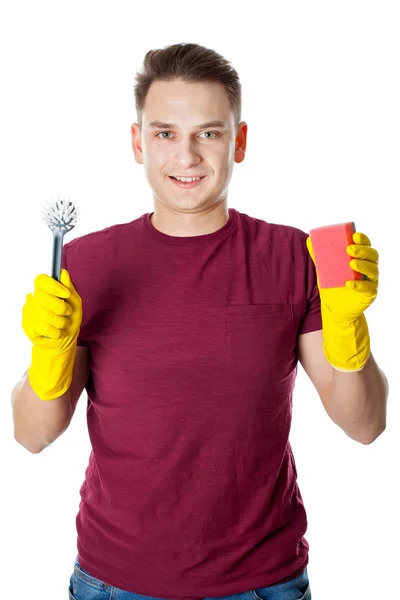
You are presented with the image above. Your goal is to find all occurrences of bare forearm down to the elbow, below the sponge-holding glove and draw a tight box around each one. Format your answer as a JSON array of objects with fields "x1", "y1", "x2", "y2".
[{"x1": 332, "y1": 354, "x2": 388, "y2": 444}]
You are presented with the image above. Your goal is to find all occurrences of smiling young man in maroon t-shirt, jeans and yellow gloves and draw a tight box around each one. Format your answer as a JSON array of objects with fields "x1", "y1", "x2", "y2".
[{"x1": 13, "y1": 44, "x2": 387, "y2": 600}]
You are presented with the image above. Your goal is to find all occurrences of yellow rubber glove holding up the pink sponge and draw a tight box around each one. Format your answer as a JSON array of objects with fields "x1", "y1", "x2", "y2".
[{"x1": 306, "y1": 232, "x2": 379, "y2": 371}]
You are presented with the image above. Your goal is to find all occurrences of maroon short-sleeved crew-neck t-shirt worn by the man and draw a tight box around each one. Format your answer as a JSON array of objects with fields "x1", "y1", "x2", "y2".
[{"x1": 63, "y1": 208, "x2": 321, "y2": 600}]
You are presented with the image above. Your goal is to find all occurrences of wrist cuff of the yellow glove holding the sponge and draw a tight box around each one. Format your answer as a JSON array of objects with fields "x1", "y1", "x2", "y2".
[{"x1": 321, "y1": 304, "x2": 371, "y2": 371}]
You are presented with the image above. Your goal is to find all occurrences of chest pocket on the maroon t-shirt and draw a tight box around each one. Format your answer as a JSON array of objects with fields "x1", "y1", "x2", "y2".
[{"x1": 226, "y1": 303, "x2": 294, "y2": 375}]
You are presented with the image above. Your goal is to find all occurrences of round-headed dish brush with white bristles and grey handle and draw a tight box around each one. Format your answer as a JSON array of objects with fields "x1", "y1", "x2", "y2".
[{"x1": 41, "y1": 196, "x2": 79, "y2": 281}]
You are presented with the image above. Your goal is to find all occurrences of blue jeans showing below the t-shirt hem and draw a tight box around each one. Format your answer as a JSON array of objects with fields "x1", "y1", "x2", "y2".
[{"x1": 69, "y1": 557, "x2": 311, "y2": 600}]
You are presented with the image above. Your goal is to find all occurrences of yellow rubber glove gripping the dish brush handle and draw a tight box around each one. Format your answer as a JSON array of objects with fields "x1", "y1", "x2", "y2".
[{"x1": 22, "y1": 269, "x2": 82, "y2": 400}]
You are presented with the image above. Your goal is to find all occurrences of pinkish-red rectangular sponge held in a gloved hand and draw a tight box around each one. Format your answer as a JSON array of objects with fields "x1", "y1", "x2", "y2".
[{"x1": 309, "y1": 222, "x2": 365, "y2": 288}]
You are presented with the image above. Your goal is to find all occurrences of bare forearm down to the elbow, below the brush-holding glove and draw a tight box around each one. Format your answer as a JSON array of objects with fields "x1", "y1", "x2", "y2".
[{"x1": 12, "y1": 372, "x2": 72, "y2": 453}]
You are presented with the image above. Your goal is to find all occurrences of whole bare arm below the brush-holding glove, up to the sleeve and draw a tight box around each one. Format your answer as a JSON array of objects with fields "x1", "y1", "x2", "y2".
[{"x1": 12, "y1": 346, "x2": 89, "y2": 454}]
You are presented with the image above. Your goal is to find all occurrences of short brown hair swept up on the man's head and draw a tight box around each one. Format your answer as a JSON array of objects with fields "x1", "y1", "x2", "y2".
[{"x1": 134, "y1": 44, "x2": 242, "y2": 128}]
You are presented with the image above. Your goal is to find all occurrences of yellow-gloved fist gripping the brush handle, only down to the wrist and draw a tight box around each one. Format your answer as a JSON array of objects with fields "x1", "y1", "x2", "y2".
[{"x1": 22, "y1": 269, "x2": 82, "y2": 353}]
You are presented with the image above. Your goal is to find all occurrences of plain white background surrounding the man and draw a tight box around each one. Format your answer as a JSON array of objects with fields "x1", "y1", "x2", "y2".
[{"x1": 0, "y1": 0, "x2": 400, "y2": 600}]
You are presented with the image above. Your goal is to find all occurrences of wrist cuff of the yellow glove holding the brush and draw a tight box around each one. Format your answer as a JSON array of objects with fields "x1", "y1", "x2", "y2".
[{"x1": 28, "y1": 342, "x2": 77, "y2": 400}]
